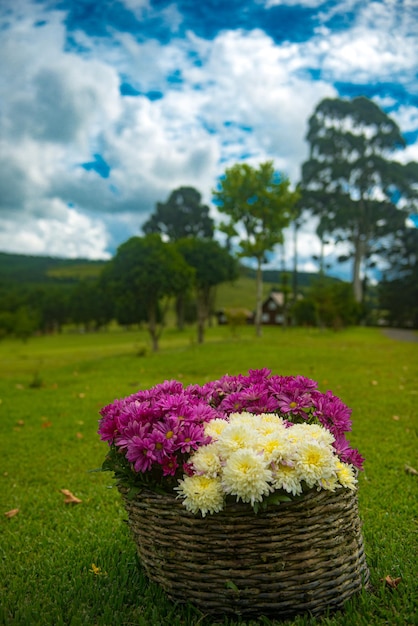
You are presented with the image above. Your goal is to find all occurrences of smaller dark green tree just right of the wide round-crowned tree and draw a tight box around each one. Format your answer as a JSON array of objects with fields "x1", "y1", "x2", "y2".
[{"x1": 177, "y1": 237, "x2": 237, "y2": 343}]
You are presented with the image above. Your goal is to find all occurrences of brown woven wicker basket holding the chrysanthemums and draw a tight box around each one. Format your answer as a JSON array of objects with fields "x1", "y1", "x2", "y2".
[{"x1": 120, "y1": 488, "x2": 369, "y2": 618}]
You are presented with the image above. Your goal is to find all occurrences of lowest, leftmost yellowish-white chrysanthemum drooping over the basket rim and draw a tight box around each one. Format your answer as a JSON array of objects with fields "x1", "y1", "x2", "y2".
[{"x1": 176, "y1": 474, "x2": 224, "y2": 517}]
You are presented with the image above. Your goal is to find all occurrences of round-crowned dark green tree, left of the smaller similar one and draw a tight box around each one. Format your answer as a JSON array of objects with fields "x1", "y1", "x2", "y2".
[{"x1": 102, "y1": 234, "x2": 193, "y2": 351}]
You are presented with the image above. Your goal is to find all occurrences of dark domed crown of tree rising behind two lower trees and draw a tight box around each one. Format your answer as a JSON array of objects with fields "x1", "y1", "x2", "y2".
[{"x1": 142, "y1": 187, "x2": 214, "y2": 241}]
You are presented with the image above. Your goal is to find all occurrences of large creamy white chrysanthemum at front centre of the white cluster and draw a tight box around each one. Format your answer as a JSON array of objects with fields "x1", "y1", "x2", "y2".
[{"x1": 222, "y1": 448, "x2": 272, "y2": 505}]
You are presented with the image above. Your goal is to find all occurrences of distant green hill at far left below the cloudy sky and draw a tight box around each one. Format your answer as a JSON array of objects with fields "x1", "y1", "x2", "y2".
[{"x1": 0, "y1": 252, "x2": 106, "y2": 284}]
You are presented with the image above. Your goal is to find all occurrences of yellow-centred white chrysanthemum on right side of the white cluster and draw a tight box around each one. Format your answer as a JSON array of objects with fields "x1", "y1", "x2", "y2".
[{"x1": 296, "y1": 439, "x2": 337, "y2": 487}]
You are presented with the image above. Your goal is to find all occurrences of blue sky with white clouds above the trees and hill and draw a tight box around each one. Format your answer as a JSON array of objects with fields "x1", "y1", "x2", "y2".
[{"x1": 0, "y1": 0, "x2": 418, "y2": 270}]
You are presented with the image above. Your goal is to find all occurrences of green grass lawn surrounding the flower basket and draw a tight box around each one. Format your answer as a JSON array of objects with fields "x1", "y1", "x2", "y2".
[{"x1": 0, "y1": 327, "x2": 418, "y2": 626}]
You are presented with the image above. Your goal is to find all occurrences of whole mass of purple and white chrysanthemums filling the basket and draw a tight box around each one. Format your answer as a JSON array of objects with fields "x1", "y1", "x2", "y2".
[{"x1": 99, "y1": 369, "x2": 364, "y2": 516}]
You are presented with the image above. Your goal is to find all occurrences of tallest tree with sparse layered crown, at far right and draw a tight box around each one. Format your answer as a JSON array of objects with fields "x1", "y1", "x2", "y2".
[{"x1": 301, "y1": 97, "x2": 418, "y2": 302}]
